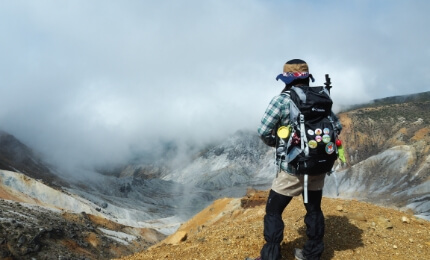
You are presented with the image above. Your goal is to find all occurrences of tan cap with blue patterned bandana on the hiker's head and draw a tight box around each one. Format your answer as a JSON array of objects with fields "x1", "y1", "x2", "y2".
[{"x1": 276, "y1": 59, "x2": 315, "y2": 85}]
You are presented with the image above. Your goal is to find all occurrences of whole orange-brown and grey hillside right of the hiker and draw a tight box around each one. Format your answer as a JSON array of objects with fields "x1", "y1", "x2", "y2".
[{"x1": 324, "y1": 92, "x2": 430, "y2": 220}]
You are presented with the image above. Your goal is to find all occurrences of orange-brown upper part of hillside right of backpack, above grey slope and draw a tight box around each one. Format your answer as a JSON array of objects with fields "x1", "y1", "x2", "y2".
[{"x1": 339, "y1": 99, "x2": 430, "y2": 166}]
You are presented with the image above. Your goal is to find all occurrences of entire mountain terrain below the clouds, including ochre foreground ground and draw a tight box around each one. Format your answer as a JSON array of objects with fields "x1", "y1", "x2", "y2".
[{"x1": 0, "y1": 92, "x2": 430, "y2": 259}]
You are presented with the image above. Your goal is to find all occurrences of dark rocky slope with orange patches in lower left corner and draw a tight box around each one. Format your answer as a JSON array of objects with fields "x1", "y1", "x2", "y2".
[{"x1": 0, "y1": 199, "x2": 165, "y2": 260}]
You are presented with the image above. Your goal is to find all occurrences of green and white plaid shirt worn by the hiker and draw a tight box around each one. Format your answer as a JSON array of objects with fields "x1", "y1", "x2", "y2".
[{"x1": 258, "y1": 94, "x2": 342, "y2": 172}]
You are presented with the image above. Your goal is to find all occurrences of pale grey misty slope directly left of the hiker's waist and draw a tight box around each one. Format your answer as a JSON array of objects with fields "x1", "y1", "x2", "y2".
[{"x1": 163, "y1": 131, "x2": 274, "y2": 196}]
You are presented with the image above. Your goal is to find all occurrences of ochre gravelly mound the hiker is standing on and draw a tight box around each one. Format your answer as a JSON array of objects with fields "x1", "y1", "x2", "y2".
[{"x1": 121, "y1": 191, "x2": 430, "y2": 260}]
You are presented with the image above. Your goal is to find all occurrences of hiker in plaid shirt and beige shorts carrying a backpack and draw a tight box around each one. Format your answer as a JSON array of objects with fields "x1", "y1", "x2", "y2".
[{"x1": 250, "y1": 59, "x2": 342, "y2": 260}]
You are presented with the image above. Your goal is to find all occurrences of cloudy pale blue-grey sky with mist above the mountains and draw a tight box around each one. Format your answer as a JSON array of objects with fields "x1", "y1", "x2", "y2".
[{"x1": 0, "y1": 0, "x2": 430, "y2": 174}]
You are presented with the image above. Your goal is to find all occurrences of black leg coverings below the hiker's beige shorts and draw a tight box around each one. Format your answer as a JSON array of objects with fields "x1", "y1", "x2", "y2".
[{"x1": 261, "y1": 190, "x2": 324, "y2": 260}]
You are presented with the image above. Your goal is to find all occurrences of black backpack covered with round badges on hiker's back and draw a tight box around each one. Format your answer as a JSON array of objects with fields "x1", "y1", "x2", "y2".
[{"x1": 283, "y1": 86, "x2": 338, "y2": 175}]
